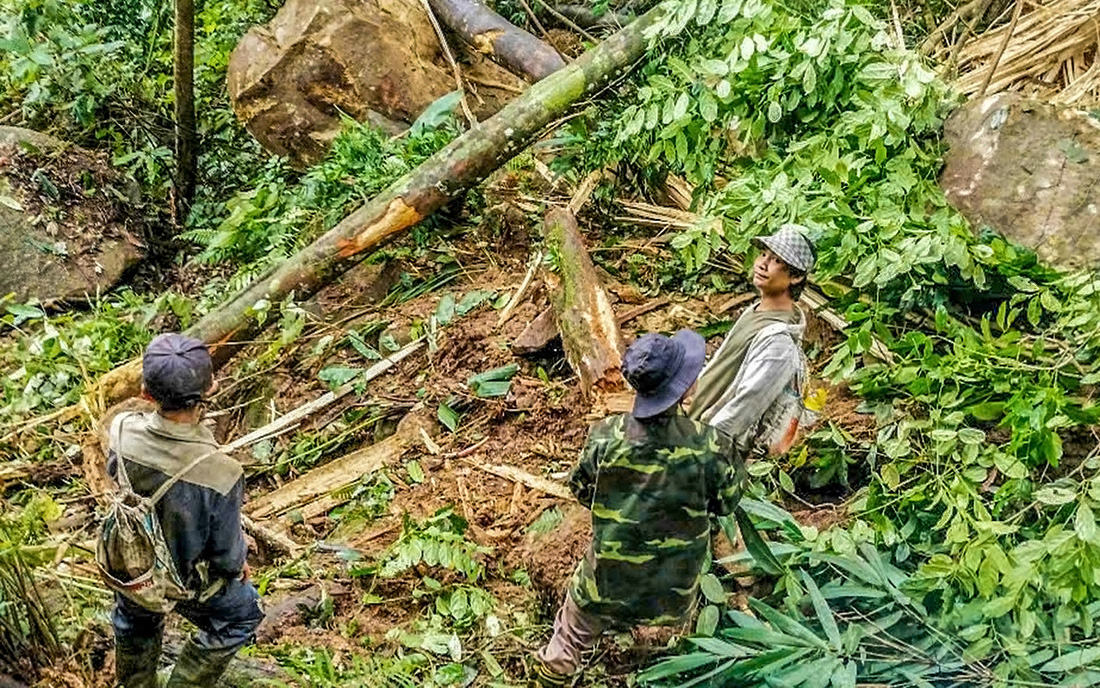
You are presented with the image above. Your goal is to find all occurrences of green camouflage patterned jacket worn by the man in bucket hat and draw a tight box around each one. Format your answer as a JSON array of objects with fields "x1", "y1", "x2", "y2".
[{"x1": 569, "y1": 411, "x2": 743, "y2": 625}]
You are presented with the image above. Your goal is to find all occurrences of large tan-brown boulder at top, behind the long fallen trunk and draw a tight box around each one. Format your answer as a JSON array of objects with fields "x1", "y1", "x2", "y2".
[{"x1": 229, "y1": 0, "x2": 524, "y2": 166}]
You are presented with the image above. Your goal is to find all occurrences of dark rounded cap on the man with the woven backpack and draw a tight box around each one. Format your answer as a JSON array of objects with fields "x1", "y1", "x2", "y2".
[{"x1": 142, "y1": 332, "x2": 213, "y2": 411}]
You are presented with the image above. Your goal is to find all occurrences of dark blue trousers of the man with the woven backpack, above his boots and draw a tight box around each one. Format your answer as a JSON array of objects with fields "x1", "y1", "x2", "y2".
[{"x1": 111, "y1": 580, "x2": 264, "y2": 651}]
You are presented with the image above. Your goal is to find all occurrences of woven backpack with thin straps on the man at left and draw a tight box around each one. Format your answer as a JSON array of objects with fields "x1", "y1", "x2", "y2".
[{"x1": 96, "y1": 418, "x2": 217, "y2": 613}]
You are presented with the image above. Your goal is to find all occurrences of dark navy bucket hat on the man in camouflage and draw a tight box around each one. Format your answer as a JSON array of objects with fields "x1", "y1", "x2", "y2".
[{"x1": 623, "y1": 329, "x2": 706, "y2": 419}]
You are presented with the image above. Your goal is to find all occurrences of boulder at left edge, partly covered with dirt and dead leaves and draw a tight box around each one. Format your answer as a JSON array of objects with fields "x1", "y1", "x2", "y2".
[{"x1": 0, "y1": 127, "x2": 142, "y2": 303}]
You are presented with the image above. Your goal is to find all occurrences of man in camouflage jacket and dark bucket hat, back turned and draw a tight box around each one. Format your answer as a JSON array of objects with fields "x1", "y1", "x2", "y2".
[{"x1": 538, "y1": 330, "x2": 741, "y2": 685}]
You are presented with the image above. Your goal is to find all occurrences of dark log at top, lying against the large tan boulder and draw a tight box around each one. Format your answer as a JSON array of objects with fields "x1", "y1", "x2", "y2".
[{"x1": 428, "y1": 0, "x2": 565, "y2": 84}]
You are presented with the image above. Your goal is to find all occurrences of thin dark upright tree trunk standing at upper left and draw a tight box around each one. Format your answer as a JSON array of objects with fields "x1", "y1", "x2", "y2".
[{"x1": 173, "y1": 0, "x2": 198, "y2": 213}]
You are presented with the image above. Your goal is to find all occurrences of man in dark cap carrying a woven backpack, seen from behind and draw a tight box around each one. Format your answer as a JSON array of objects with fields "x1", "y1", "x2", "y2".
[{"x1": 103, "y1": 334, "x2": 263, "y2": 688}]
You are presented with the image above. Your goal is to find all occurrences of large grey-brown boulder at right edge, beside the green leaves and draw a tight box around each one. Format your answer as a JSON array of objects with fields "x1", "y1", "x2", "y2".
[{"x1": 941, "y1": 94, "x2": 1100, "y2": 269}]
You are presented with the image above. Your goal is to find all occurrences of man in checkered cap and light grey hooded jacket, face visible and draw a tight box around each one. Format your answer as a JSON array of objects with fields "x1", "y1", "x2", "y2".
[{"x1": 689, "y1": 225, "x2": 816, "y2": 456}]
